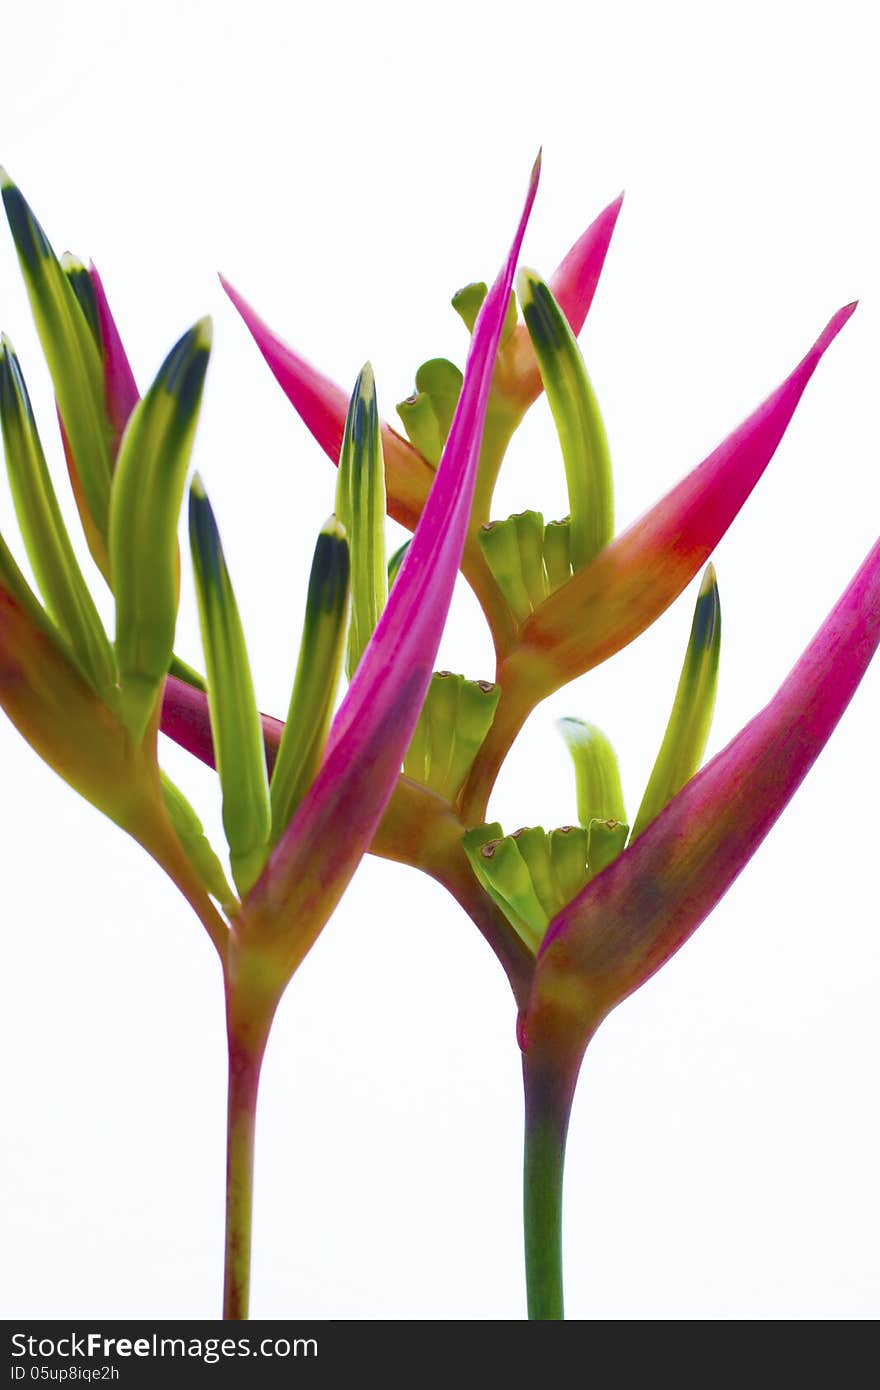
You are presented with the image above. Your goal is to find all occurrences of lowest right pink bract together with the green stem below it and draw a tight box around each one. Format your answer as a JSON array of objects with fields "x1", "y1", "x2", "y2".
[{"x1": 519, "y1": 542, "x2": 880, "y2": 1318}]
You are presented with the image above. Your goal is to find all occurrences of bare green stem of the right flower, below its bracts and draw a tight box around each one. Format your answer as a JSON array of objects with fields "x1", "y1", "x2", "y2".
[{"x1": 523, "y1": 1052, "x2": 574, "y2": 1322}]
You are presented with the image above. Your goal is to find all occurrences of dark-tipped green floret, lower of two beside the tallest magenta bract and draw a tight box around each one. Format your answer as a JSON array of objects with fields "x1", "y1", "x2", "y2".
[{"x1": 270, "y1": 517, "x2": 350, "y2": 844}]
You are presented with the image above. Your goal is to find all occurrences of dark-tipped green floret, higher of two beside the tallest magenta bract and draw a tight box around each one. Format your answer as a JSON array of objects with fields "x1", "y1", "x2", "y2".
[{"x1": 336, "y1": 363, "x2": 388, "y2": 680}]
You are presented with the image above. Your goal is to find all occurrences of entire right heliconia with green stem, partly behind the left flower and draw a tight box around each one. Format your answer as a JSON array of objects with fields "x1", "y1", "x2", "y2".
[{"x1": 163, "y1": 179, "x2": 880, "y2": 1318}]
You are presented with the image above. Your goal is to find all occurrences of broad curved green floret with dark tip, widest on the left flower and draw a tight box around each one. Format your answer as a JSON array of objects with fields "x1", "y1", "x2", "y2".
[{"x1": 110, "y1": 318, "x2": 211, "y2": 735}]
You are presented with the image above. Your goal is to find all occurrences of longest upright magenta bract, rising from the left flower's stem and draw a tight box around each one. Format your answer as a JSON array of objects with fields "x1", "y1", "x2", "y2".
[{"x1": 229, "y1": 164, "x2": 539, "y2": 970}]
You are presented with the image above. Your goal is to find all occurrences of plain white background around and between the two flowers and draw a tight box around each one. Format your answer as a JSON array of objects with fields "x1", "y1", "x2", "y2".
[{"x1": 0, "y1": 0, "x2": 880, "y2": 1319}]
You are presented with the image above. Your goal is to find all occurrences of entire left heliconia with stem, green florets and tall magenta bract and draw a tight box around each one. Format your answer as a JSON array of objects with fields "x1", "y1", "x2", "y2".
[{"x1": 0, "y1": 165, "x2": 538, "y2": 1318}]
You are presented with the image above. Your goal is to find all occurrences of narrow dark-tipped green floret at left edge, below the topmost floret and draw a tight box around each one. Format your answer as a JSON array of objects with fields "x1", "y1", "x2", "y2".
[{"x1": 0, "y1": 335, "x2": 115, "y2": 703}]
